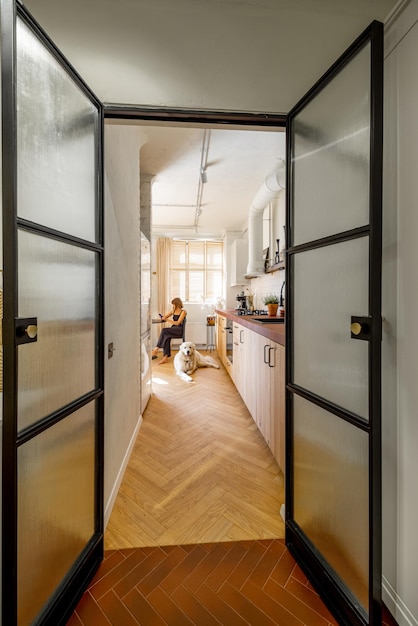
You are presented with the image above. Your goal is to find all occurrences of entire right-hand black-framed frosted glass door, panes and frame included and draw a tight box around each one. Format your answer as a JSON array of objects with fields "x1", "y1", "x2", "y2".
[{"x1": 286, "y1": 23, "x2": 382, "y2": 625}]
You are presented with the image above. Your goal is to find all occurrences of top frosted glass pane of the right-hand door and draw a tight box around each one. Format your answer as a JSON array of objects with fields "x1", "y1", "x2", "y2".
[{"x1": 292, "y1": 45, "x2": 370, "y2": 245}]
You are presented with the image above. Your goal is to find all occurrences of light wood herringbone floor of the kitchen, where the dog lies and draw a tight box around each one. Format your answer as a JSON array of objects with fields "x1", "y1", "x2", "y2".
[{"x1": 105, "y1": 348, "x2": 284, "y2": 549}]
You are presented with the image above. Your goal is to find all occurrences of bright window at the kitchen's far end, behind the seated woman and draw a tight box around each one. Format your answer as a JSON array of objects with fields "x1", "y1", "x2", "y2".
[{"x1": 170, "y1": 241, "x2": 223, "y2": 303}]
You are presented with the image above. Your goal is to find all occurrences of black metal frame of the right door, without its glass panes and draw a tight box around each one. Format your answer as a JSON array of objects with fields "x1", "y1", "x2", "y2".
[{"x1": 286, "y1": 22, "x2": 383, "y2": 626}]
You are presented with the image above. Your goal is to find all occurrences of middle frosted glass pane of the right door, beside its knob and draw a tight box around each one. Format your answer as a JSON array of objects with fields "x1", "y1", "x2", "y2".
[{"x1": 293, "y1": 237, "x2": 369, "y2": 419}]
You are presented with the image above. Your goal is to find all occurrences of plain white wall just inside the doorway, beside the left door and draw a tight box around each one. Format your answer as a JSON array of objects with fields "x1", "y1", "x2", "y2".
[{"x1": 104, "y1": 125, "x2": 141, "y2": 523}]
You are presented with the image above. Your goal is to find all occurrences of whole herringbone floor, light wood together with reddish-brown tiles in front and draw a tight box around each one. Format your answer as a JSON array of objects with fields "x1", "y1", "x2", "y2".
[{"x1": 68, "y1": 348, "x2": 396, "y2": 626}]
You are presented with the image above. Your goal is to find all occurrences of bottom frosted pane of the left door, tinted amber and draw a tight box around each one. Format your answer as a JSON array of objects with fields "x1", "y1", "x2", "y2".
[{"x1": 17, "y1": 402, "x2": 96, "y2": 624}]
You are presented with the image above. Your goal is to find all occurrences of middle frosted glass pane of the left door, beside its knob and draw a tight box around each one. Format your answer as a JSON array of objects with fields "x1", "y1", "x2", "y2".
[{"x1": 18, "y1": 231, "x2": 97, "y2": 430}]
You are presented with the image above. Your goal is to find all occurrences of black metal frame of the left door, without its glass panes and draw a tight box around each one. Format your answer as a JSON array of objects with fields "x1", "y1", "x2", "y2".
[{"x1": 1, "y1": 0, "x2": 104, "y2": 626}]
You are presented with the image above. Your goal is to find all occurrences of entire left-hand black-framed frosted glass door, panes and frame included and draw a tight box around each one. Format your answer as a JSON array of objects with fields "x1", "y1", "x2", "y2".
[{"x1": 1, "y1": 0, "x2": 103, "y2": 626}]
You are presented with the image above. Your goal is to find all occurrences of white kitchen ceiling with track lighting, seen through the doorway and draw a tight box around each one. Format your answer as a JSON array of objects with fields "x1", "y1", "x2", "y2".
[{"x1": 134, "y1": 126, "x2": 285, "y2": 238}]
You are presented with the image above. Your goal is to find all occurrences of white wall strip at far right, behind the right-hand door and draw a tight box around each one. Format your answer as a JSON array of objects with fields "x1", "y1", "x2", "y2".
[{"x1": 382, "y1": 0, "x2": 418, "y2": 626}]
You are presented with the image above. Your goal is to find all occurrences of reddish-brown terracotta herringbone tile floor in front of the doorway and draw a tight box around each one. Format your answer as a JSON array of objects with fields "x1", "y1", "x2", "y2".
[{"x1": 68, "y1": 539, "x2": 396, "y2": 626}]
